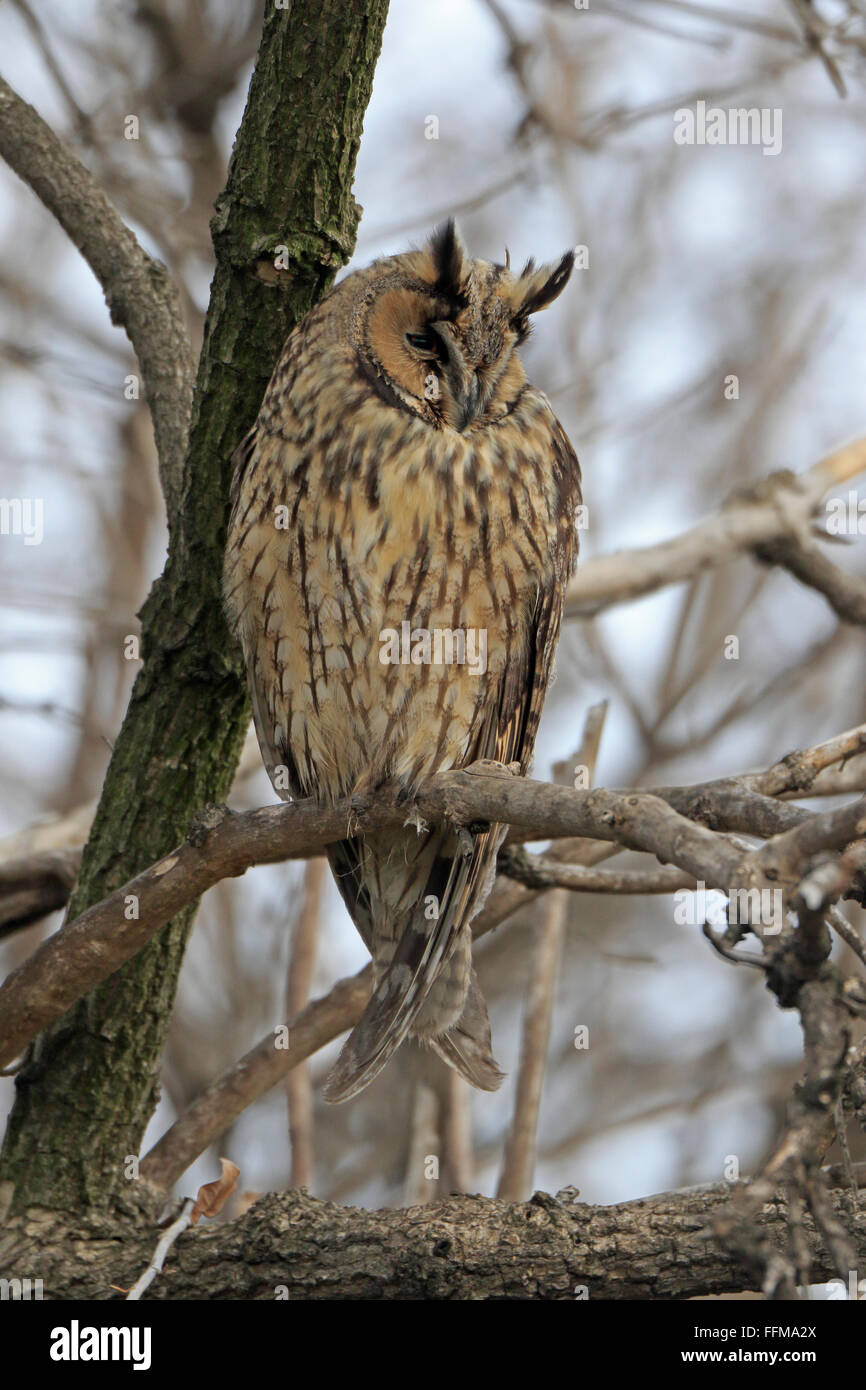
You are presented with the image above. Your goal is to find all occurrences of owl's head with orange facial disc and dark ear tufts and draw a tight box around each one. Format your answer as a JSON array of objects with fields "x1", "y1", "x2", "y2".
[{"x1": 343, "y1": 221, "x2": 574, "y2": 432}]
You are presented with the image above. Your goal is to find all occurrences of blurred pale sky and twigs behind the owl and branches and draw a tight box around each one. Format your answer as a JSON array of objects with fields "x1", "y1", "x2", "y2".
[{"x1": 0, "y1": 0, "x2": 866, "y2": 1205}]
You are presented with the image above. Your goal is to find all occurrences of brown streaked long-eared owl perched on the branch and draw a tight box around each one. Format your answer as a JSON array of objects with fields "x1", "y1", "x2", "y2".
[{"x1": 224, "y1": 221, "x2": 580, "y2": 1101}]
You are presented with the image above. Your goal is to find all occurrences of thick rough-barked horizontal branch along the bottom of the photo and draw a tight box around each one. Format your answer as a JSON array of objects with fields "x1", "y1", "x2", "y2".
[{"x1": 4, "y1": 1183, "x2": 866, "y2": 1302}]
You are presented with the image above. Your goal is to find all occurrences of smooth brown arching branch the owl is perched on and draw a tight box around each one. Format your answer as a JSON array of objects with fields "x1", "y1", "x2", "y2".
[{"x1": 0, "y1": 763, "x2": 863, "y2": 1066}]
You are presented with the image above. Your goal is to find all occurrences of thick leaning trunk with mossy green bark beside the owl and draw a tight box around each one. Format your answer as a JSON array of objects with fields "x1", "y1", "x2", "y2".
[{"x1": 0, "y1": 0, "x2": 388, "y2": 1211}]
